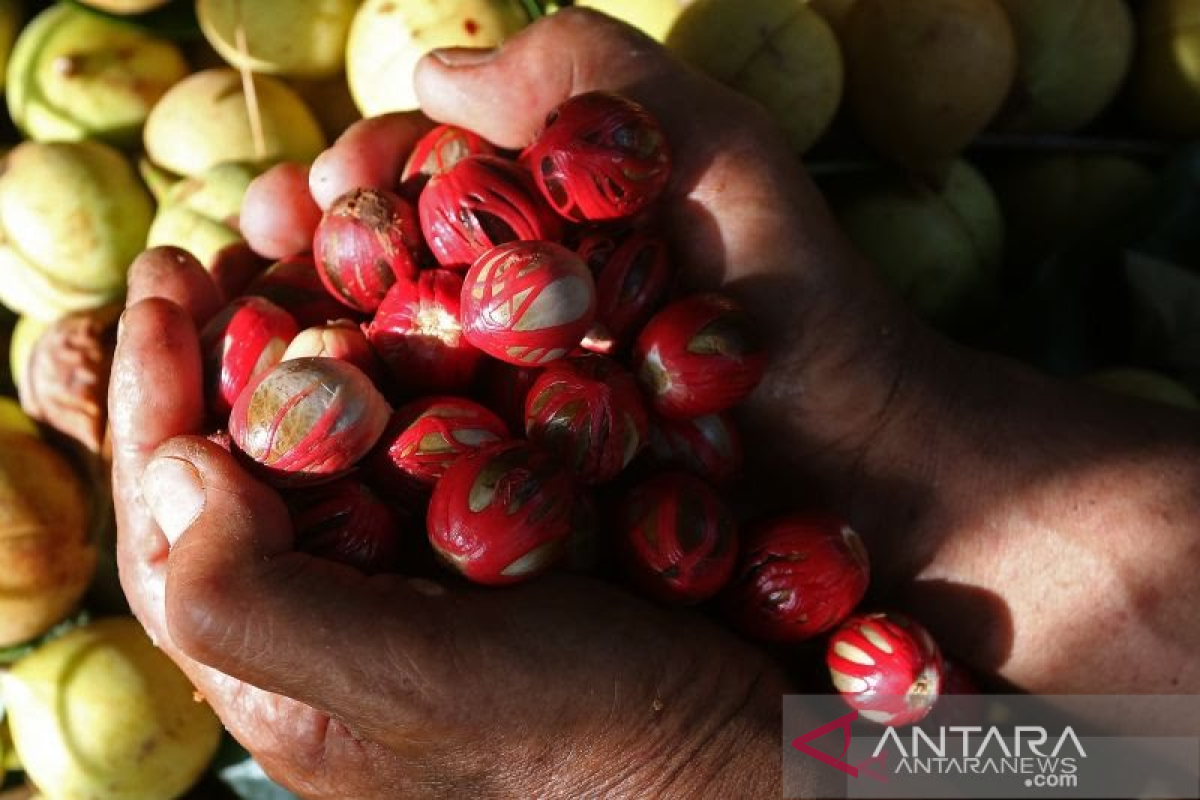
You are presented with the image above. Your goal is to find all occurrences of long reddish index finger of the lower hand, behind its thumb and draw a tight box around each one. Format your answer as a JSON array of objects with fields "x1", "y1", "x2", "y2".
[{"x1": 108, "y1": 297, "x2": 204, "y2": 604}]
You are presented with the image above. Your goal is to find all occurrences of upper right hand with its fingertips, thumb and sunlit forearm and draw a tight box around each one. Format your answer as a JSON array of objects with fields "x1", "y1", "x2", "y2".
[{"x1": 234, "y1": 4, "x2": 1200, "y2": 705}]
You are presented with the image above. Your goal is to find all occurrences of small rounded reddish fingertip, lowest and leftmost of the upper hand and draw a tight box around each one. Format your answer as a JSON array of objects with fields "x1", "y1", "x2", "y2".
[{"x1": 240, "y1": 162, "x2": 320, "y2": 260}]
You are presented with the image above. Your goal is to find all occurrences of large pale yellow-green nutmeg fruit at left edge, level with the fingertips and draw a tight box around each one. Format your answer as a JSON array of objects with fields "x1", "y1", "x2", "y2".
[{"x1": 0, "y1": 140, "x2": 152, "y2": 320}]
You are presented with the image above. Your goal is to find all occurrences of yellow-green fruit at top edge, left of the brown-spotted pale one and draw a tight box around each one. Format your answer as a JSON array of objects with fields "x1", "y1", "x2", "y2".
[{"x1": 196, "y1": 0, "x2": 359, "y2": 78}]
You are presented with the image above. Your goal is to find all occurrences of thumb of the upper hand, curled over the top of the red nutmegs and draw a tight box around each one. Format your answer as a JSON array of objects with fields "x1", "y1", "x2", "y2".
[{"x1": 414, "y1": 8, "x2": 736, "y2": 149}]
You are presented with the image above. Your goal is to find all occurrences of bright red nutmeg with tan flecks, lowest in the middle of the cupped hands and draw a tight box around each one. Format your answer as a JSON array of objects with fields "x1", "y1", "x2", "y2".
[{"x1": 426, "y1": 441, "x2": 576, "y2": 585}]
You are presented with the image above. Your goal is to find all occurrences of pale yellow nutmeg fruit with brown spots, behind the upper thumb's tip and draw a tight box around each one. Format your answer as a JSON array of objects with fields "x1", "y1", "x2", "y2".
[{"x1": 346, "y1": 0, "x2": 528, "y2": 116}]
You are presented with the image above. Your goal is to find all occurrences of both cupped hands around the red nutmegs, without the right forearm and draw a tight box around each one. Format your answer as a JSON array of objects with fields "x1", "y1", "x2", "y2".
[{"x1": 109, "y1": 10, "x2": 1051, "y2": 798}]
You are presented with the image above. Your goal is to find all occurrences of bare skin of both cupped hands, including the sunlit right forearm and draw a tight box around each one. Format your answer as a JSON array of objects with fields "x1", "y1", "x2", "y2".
[{"x1": 110, "y1": 11, "x2": 1200, "y2": 798}]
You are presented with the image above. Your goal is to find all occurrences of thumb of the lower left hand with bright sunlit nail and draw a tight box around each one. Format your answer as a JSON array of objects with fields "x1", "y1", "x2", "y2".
[{"x1": 142, "y1": 437, "x2": 446, "y2": 729}]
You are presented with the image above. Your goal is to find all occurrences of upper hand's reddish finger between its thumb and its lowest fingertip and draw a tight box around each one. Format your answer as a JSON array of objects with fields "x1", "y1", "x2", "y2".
[{"x1": 308, "y1": 112, "x2": 432, "y2": 209}]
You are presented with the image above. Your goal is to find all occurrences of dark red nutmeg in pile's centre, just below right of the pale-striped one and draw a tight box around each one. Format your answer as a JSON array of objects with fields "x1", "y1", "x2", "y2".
[{"x1": 526, "y1": 355, "x2": 649, "y2": 483}]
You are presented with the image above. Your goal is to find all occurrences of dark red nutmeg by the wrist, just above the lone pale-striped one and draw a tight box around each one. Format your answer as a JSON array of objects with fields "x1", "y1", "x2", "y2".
[{"x1": 726, "y1": 513, "x2": 870, "y2": 642}]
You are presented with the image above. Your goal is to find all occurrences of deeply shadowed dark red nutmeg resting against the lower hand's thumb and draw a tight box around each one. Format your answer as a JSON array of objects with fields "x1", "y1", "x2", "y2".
[{"x1": 283, "y1": 477, "x2": 401, "y2": 575}]
